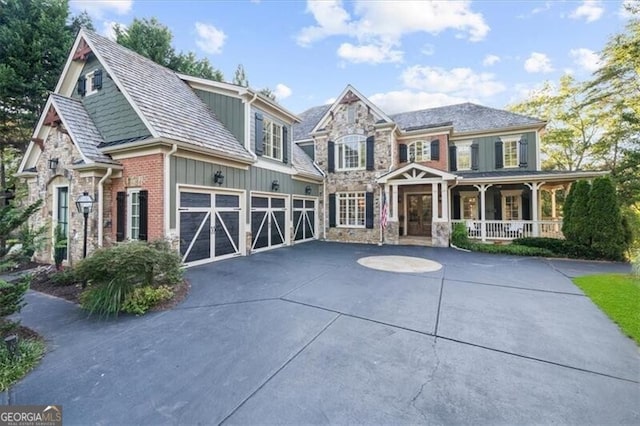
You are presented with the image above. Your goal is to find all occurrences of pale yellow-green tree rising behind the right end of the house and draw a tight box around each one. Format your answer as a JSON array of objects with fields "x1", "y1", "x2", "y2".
[{"x1": 508, "y1": 75, "x2": 610, "y2": 171}]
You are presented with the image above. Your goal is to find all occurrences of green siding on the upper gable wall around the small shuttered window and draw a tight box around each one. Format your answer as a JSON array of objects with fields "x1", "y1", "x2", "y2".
[{"x1": 72, "y1": 56, "x2": 151, "y2": 142}]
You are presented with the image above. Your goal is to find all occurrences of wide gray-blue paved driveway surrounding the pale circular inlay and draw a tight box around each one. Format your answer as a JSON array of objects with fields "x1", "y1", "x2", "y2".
[{"x1": 5, "y1": 242, "x2": 640, "y2": 424}]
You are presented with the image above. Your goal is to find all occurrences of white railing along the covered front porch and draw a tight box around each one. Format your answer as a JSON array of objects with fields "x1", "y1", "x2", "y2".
[{"x1": 451, "y1": 219, "x2": 564, "y2": 241}]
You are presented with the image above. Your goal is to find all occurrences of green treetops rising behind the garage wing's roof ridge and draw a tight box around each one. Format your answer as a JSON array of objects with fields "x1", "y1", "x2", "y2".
[{"x1": 114, "y1": 18, "x2": 223, "y2": 81}]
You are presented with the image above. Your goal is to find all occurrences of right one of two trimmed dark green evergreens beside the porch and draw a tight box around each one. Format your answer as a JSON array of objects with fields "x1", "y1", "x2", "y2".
[{"x1": 588, "y1": 176, "x2": 628, "y2": 260}]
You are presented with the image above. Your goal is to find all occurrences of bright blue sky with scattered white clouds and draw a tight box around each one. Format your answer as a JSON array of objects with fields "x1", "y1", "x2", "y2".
[{"x1": 70, "y1": 0, "x2": 633, "y2": 114}]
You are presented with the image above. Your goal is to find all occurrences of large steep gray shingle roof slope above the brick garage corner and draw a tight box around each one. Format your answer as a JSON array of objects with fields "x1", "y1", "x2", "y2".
[{"x1": 83, "y1": 30, "x2": 253, "y2": 160}]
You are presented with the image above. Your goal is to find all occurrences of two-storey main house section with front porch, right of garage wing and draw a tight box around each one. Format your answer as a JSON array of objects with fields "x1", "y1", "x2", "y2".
[{"x1": 294, "y1": 85, "x2": 602, "y2": 246}]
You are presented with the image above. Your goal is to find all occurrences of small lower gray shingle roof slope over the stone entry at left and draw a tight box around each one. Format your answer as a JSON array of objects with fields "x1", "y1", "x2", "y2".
[{"x1": 51, "y1": 94, "x2": 118, "y2": 164}]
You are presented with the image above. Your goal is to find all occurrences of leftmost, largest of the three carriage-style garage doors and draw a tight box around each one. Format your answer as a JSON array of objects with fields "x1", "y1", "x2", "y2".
[{"x1": 178, "y1": 190, "x2": 244, "y2": 264}]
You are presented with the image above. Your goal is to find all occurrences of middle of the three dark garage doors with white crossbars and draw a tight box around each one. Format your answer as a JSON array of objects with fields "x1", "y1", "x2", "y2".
[{"x1": 251, "y1": 195, "x2": 287, "y2": 251}]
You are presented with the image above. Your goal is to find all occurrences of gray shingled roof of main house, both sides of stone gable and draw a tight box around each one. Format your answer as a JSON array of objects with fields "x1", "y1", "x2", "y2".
[{"x1": 293, "y1": 103, "x2": 544, "y2": 141}]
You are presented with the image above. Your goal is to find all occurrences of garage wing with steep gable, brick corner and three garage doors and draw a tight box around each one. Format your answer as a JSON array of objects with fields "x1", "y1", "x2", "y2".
[{"x1": 19, "y1": 29, "x2": 323, "y2": 265}]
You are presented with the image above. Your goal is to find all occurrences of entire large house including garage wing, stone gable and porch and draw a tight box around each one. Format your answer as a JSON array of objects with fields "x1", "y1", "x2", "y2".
[{"x1": 19, "y1": 29, "x2": 596, "y2": 265}]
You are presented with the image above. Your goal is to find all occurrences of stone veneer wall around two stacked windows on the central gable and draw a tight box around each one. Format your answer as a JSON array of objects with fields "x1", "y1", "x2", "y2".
[{"x1": 316, "y1": 97, "x2": 393, "y2": 244}]
